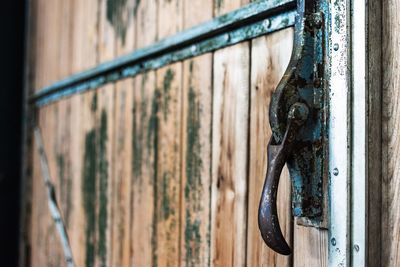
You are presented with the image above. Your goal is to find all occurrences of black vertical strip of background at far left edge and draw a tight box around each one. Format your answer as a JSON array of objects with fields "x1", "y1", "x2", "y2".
[{"x1": 0, "y1": 0, "x2": 26, "y2": 267}]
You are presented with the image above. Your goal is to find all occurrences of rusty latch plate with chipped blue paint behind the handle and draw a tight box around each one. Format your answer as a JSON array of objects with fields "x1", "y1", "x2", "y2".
[{"x1": 269, "y1": 1, "x2": 326, "y2": 225}]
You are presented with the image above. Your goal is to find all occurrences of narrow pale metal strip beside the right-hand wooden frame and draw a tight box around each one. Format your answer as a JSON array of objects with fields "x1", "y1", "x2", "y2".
[{"x1": 350, "y1": 0, "x2": 368, "y2": 266}]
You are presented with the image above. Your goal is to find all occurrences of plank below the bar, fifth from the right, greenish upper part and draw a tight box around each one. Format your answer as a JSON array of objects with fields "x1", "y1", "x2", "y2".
[{"x1": 130, "y1": 71, "x2": 159, "y2": 266}]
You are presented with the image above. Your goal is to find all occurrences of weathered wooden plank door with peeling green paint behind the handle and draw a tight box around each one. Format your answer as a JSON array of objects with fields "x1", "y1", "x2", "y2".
[{"x1": 21, "y1": 0, "x2": 382, "y2": 266}]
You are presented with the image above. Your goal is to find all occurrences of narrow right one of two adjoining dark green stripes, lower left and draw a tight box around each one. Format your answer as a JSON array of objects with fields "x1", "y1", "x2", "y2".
[{"x1": 98, "y1": 110, "x2": 108, "y2": 266}]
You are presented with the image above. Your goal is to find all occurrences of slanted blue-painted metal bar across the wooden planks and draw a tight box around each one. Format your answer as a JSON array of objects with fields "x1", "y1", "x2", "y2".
[{"x1": 30, "y1": 0, "x2": 296, "y2": 106}]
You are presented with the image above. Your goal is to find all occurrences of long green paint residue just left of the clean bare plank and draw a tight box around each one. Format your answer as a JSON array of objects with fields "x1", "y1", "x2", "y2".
[{"x1": 184, "y1": 61, "x2": 203, "y2": 266}]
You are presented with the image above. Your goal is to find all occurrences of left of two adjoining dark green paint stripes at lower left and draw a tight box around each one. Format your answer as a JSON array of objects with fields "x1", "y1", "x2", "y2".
[{"x1": 82, "y1": 130, "x2": 97, "y2": 267}]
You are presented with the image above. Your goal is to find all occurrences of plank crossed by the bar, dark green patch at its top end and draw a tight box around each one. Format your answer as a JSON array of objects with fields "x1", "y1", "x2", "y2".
[{"x1": 107, "y1": 0, "x2": 138, "y2": 266}]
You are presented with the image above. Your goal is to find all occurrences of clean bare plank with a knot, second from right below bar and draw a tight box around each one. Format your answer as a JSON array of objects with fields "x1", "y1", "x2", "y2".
[{"x1": 211, "y1": 43, "x2": 250, "y2": 266}]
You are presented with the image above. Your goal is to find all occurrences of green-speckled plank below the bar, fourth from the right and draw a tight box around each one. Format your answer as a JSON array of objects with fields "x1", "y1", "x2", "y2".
[{"x1": 155, "y1": 63, "x2": 182, "y2": 266}]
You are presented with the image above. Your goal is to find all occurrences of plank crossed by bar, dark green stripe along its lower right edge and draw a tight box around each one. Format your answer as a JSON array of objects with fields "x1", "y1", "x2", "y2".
[{"x1": 68, "y1": 0, "x2": 99, "y2": 266}]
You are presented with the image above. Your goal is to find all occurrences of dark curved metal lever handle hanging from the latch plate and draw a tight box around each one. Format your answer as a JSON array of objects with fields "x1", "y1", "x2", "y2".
[{"x1": 258, "y1": 103, "x2": 308, "y2": 255}]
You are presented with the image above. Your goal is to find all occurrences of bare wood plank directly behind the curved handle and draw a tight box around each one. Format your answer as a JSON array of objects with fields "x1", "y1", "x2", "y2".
[{"x1": 247, "y1": 29, "x2": 293, "y2": 266}]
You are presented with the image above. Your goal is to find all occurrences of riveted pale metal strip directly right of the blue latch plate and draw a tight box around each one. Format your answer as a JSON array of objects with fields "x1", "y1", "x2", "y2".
[{"x1": 328, "y1": 0, "x2": 351, "y2": 266}]
